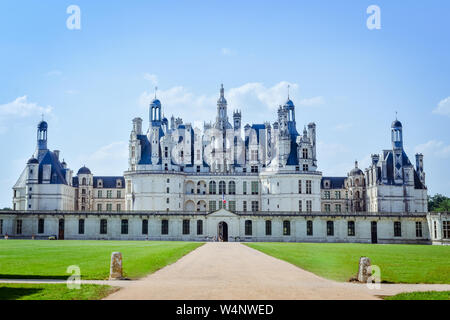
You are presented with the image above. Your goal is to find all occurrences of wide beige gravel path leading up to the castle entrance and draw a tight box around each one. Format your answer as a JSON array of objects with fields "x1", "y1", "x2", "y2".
[{"x1": 0, "y1": 242, "x2": 450, "y2": 300}]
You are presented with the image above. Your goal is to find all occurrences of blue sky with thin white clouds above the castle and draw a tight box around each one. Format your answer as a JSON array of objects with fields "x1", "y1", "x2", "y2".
[{"x1": 0, "y1": 0, "x2": 450, "y2": 208}]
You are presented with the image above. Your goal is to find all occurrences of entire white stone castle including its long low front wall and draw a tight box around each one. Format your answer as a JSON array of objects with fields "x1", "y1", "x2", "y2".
[{"x1": 0, "y1": 86, "x2": 450, "y2": 242}]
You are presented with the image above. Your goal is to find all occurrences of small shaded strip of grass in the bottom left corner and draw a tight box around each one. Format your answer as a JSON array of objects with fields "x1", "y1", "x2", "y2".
[{"x1": 0, "y1": 284, "x2": 117, "y2": 300}]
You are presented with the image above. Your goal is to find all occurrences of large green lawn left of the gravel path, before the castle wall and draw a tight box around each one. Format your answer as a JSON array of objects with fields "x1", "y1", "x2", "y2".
[{"x1": 0, "y1": 240, "x2": 202, "y2": 280}]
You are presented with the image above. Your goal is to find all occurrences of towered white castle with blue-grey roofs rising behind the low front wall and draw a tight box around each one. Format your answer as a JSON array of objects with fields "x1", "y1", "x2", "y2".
[{"x1": 0, "y1": 85, "x2": 446, "y2": 244}]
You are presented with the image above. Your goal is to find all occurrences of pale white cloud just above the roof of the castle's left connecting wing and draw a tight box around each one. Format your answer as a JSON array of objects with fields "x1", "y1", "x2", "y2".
[{"x1": 75, "y1": 141, "x2": 128, "y2": 175}]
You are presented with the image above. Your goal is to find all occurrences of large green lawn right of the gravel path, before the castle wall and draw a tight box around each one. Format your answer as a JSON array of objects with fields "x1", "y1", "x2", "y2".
[{"x1": 247, "y1": 243, "x2": 450, "y2": 284}]
